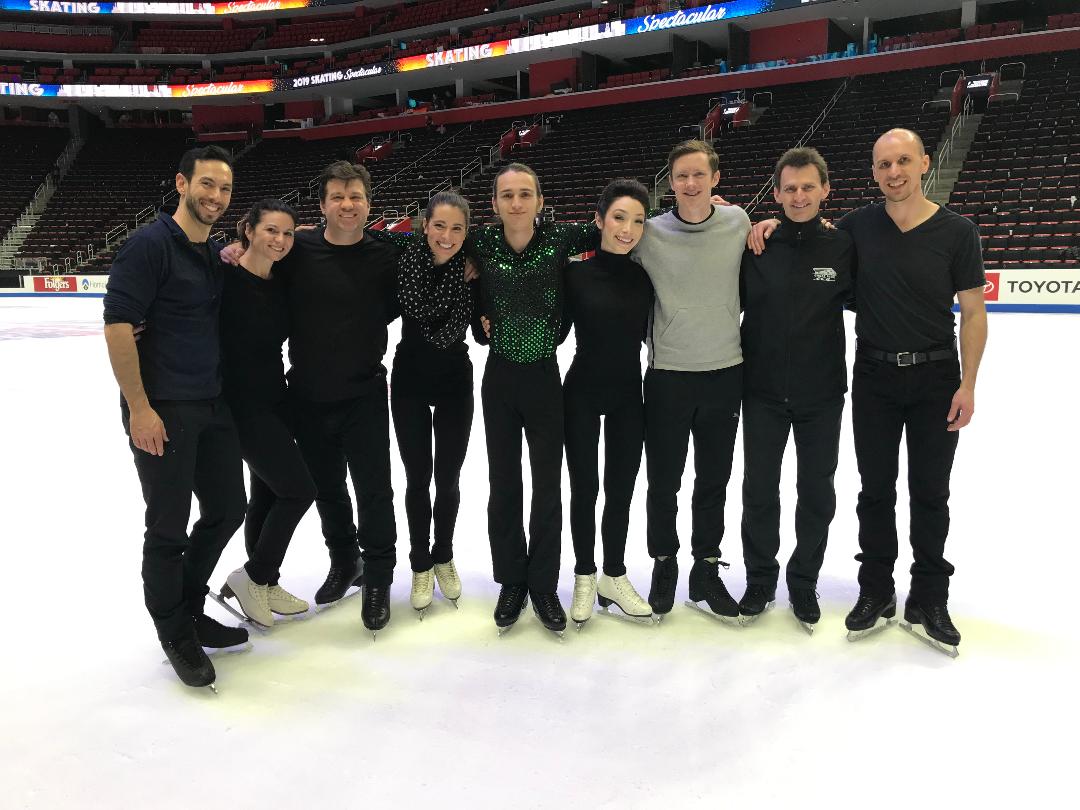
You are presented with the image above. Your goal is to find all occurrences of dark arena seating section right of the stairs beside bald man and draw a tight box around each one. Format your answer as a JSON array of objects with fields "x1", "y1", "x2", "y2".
[{"x1": 949, "y1": 51, "x2": 1080, "y2": 268}]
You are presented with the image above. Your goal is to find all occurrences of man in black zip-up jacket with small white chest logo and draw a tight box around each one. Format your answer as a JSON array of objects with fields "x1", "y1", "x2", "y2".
[{"x1": 739, "y1": 148, "x2": 855, "y2": 632}]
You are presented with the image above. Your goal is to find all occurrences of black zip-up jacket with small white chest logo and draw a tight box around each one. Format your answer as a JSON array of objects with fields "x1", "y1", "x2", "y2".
[{"x1": 740, "y1": 216, "x2": 855, "y2": 407}]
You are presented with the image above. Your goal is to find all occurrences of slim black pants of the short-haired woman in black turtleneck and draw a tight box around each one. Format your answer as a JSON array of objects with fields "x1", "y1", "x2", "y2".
[{"x1": 563, "y1": 367, "x2": 645, "y2": 577}]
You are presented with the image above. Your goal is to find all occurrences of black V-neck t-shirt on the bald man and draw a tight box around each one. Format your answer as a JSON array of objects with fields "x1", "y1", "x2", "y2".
[{"x1": 840, "y1": 203, "x2": 986, "y2": 352}]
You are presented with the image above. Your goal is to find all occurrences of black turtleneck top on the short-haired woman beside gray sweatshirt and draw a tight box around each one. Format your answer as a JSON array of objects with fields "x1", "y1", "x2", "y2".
[{"x1": 562, "y1": 249, "x2": 652, "y2": 389}]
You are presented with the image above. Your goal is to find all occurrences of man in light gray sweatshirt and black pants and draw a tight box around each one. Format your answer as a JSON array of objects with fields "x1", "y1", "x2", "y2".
[{"x1": 635, "y1": 140, "x2": 751, "y2": 622}]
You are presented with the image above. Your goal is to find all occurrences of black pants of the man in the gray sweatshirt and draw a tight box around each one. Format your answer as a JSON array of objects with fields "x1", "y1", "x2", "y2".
[{"x1": 645, "y1": 364, "x2": 742, "y2": 559}]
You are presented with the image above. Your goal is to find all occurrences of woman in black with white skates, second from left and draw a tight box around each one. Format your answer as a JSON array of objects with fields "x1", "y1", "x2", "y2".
[{"x1": 210, "y1": 200, "x2": 315, "y2": 627}]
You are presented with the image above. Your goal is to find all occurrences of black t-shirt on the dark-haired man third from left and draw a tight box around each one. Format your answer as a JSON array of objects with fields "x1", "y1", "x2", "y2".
[{"x1": 274, "y1": 228, "x2": 400, "y2": 402}]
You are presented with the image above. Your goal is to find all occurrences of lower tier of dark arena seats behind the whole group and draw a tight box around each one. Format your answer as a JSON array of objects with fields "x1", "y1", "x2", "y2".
[{"x1": 2, "y1": 52, "x2": 1080, "y2": 270}]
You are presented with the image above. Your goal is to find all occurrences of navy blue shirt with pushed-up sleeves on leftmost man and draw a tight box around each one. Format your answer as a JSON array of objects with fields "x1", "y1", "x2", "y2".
[{"x1": 105, "y1": 212, "x2": 225, "y2": 400}]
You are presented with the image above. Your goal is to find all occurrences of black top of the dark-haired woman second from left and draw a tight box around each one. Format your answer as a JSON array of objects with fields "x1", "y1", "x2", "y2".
[{"x1": 221, "y1": 265, "x2": 288, "y2": 414}]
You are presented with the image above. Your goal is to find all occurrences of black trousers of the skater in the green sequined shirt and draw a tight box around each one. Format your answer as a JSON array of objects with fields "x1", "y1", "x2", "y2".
[{"x1": 481, "y1": 352, "x2": 563, "y2": 593}]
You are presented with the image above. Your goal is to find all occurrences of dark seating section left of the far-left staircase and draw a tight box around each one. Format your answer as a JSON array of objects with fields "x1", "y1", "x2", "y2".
[{"x1": 0, "y1": 126, "x2": 70, "y2": 239}]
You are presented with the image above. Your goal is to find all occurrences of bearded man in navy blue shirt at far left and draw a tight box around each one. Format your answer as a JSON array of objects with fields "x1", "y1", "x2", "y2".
[{"x1": 105, "y1": 147, "x2": 247, "y2": 686}]
